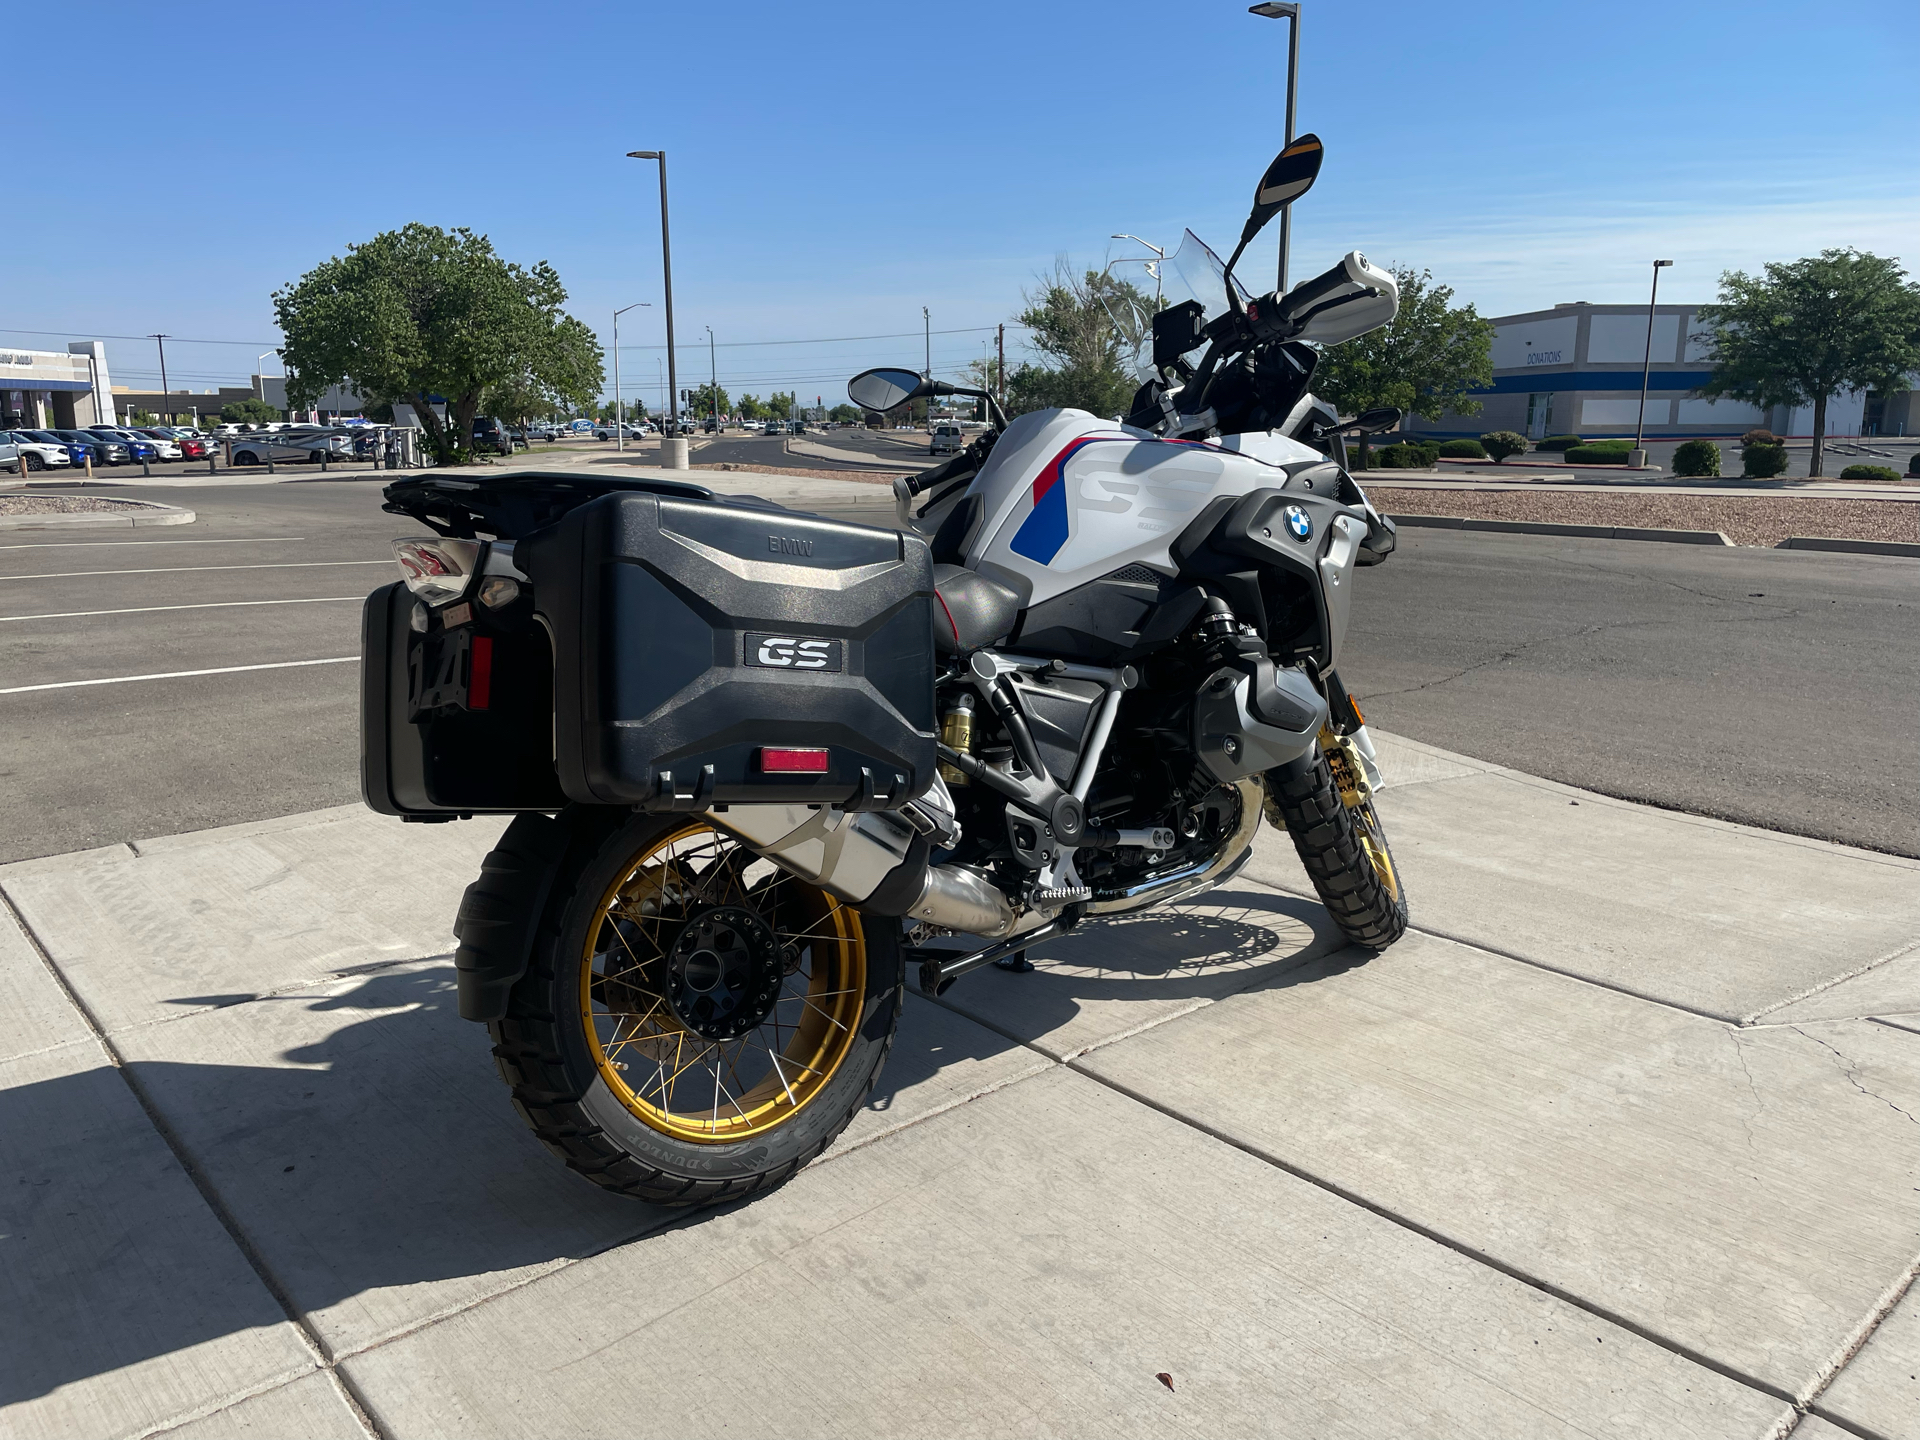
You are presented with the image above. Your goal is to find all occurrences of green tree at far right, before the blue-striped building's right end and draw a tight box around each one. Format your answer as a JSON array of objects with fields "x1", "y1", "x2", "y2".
[{"x1": 1693, "y1": 248, "x2": 1920, "y2": 474}]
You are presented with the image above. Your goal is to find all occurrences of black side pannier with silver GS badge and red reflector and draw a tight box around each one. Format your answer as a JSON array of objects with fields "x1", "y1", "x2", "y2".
[{"x1": 515, "y1": 493, "x2": 935, "y2": 810}]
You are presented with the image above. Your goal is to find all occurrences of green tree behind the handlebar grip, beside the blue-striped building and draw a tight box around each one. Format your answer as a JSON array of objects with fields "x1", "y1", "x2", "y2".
[{"x1": 1313, "y1": 265, "x2": 1494, "y2": 468}]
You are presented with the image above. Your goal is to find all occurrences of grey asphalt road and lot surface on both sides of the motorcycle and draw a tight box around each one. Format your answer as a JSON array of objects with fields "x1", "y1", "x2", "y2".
[{"x1": 0, "y1": 480, "x2": 1920, "y2": 860}]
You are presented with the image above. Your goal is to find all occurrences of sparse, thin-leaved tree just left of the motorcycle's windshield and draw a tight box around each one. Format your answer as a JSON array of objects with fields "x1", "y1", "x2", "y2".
[{"x1": 1006, "y1": 259, "x2": 1150, "y2": 415}]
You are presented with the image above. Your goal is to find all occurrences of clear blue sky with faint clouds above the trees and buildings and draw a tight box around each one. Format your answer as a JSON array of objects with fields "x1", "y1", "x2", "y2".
[{"x1": 0, "y1": 0, "x2": 1920, "y2": 403}]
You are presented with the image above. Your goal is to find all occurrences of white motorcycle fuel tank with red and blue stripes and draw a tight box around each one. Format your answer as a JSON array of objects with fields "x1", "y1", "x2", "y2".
[{"x1": 966, "y1": 411, "x2": 1325, "y2": 605}]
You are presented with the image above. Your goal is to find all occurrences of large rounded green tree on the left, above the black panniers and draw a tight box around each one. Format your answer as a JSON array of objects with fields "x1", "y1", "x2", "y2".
[{"x1": 273, "y1": 225, "x2": 603, "y2": 465}]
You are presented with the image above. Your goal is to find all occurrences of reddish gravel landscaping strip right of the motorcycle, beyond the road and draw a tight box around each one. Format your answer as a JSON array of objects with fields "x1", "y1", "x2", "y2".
[{"x1": 1375, "y1": 486, "x2": 1920, "y2": 545}]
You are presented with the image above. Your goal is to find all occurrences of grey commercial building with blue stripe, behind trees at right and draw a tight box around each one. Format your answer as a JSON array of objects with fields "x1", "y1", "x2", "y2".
[{"x1": 1407, "y1": 301, "x2": 1920, "y2": 440}]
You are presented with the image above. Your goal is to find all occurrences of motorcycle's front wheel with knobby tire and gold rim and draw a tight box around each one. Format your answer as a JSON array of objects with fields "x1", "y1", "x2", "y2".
[{"x1": 1267, "y1": 732, "x2": 1407, "y2": 950}]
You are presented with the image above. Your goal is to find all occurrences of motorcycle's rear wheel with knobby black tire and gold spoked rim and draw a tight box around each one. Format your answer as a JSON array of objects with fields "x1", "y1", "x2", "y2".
[{"x1": 490, "y1": 814, "x2": 904, "y2": 1206}]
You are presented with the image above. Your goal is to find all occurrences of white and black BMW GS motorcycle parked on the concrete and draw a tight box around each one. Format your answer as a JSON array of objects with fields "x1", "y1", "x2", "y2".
[{"x1": 361, "y1": 136, "x2": 1407, "y2": 1206}]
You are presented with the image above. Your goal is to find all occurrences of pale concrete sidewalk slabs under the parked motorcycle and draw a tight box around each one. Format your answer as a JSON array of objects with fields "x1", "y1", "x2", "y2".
[{"x1": 0, "y1": 737, "x2": 1920, "y2": 1440}]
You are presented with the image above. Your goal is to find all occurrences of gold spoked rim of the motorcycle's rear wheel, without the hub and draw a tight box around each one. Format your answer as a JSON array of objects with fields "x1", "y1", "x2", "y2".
[{"x1": 580, "y1": 822, "x2": 866, "y2": 1144}]
